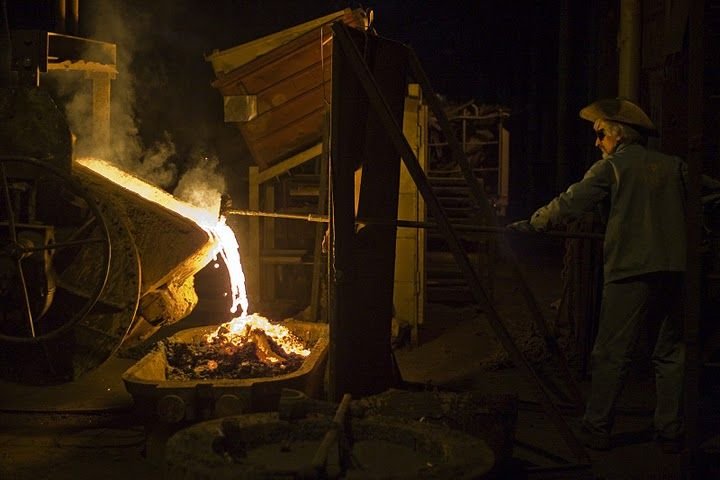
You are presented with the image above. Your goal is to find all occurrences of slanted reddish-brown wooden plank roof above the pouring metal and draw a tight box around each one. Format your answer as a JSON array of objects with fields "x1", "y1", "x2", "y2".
[{"x1": 208, "y1": 9, "x2": 366, "y2": 170}]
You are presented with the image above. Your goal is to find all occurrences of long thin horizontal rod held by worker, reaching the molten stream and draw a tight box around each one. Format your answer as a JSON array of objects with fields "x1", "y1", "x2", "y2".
[{"x1": 223, "y1": 210, "x2": 605, "y2": 240}]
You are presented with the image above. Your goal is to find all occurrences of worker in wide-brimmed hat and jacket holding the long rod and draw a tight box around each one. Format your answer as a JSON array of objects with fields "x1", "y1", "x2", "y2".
[{"x1": 508, "y1": 98, "x2": 720, "y2": 452}]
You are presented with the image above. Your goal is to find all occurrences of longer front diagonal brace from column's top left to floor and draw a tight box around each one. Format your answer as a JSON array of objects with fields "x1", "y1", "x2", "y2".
[{"x1": 332, "y1": 22, "x2": 589, "y2": 461}]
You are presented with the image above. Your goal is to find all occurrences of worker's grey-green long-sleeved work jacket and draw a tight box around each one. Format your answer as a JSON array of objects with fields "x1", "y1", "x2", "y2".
[{"x1": 530, "y1": 144, "x2": 687, "y2": 283}]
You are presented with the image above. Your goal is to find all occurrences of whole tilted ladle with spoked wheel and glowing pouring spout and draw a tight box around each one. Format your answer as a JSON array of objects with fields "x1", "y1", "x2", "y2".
[{"x1": 0, "y1": 147, "x2": 231, "y2": 384}]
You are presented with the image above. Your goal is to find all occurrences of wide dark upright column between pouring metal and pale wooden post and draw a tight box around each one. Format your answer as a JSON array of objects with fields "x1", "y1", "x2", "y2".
[{"x1": 330, "y1": 30, "x2": 407, "y2": 398}]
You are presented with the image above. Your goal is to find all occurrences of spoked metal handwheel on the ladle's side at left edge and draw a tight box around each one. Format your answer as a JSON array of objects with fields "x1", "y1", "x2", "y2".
[{"x1": 0, "y1": 156, "x2": 111, "y2": 343}]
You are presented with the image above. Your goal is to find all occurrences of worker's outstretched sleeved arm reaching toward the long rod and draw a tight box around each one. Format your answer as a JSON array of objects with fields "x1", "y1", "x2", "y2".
[{"x1": 530, "y1": 159, "x2": 615, "y2": 231}]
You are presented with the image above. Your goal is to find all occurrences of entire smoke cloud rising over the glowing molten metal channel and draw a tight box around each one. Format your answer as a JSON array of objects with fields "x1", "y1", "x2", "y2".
[{"x1": 44, "y1": 0, "x2": 233, "y2": 207}]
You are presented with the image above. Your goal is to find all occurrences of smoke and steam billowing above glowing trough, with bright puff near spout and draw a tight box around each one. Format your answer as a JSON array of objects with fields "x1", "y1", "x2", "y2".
[{"x1": 53, "y1": 0, "x2": 225, "y2": 202}]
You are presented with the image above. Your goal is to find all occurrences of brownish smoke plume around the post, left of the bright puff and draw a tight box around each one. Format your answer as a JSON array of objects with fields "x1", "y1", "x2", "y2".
[{"x1": 46, "y1": 0, "x2": 178, "y2": 189}]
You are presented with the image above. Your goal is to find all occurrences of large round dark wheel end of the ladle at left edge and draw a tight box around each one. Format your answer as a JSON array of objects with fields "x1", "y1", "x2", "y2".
[{"x1": 0, "y1": 156, "x2": 129, "y2": 383}]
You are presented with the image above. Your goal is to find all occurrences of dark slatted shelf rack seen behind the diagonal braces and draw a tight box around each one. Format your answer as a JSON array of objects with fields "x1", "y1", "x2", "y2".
[{"x1": 426, "y1": 102, "x2": 510, "y2": 302}]
